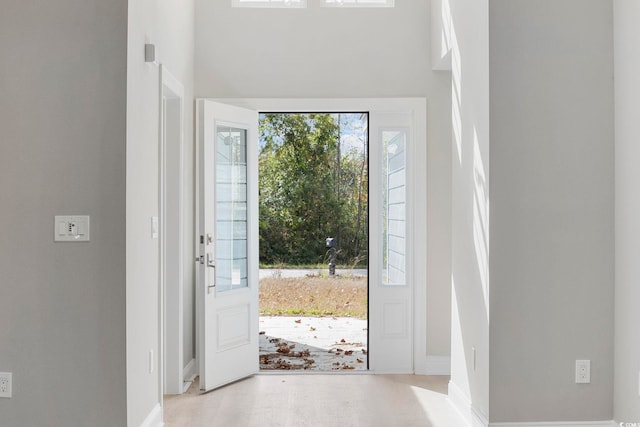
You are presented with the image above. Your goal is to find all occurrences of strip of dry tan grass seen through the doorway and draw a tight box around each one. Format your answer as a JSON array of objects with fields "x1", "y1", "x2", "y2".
[{"x1": 260, "y1": 276, "x2": 367, "y2": 319}]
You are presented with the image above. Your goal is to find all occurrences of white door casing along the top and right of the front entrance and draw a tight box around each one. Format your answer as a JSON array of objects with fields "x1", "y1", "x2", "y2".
[{"x1": 196, "y1": 98, "x2": 427, "y2": 375}]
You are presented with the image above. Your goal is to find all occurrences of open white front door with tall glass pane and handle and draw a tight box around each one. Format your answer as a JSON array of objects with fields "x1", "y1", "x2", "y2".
[{"x1": 196, "y1": 100, "x2": 259, "y2": 391}]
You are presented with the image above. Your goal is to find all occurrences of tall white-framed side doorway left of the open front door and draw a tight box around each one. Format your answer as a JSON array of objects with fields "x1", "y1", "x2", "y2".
[{"x1": 158, "y1": 65, "x2": 185, "y2": 396}]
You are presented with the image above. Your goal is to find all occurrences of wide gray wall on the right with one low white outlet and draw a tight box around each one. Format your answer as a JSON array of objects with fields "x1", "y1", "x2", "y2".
[{"x1": 489, "y1": 0, "x2": 614, "y2": 422}]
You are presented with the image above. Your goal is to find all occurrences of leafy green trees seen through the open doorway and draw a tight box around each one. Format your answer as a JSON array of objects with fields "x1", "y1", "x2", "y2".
[{"x1": 259, "y1": 113, "x2": 368, "y2": 266}]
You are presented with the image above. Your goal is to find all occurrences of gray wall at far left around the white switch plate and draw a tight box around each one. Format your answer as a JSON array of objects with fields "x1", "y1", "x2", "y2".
[{"x1": 0, "y1": 0, "x2": 127, "y2": 427}]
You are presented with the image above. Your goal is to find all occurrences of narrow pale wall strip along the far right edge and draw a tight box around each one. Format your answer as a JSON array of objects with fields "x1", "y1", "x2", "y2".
[{"x1": 613, "y1": 0, "x2": 640, "y2": 422}]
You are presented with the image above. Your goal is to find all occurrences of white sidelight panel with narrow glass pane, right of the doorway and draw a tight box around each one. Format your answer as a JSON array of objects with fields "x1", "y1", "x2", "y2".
[{"x1": 369, "y1": 111, "x2": 415, "y2": 373}]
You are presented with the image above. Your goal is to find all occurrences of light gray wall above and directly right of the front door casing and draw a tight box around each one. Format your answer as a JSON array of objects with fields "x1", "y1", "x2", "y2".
[{"x1": 195, "y1": 0, "x2": 451, "y2": 362}]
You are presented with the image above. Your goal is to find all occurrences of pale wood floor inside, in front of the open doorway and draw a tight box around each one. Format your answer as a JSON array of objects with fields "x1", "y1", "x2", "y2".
[{"x1": 164, "y1": 374, "x2": 465, "y2": 427}]
